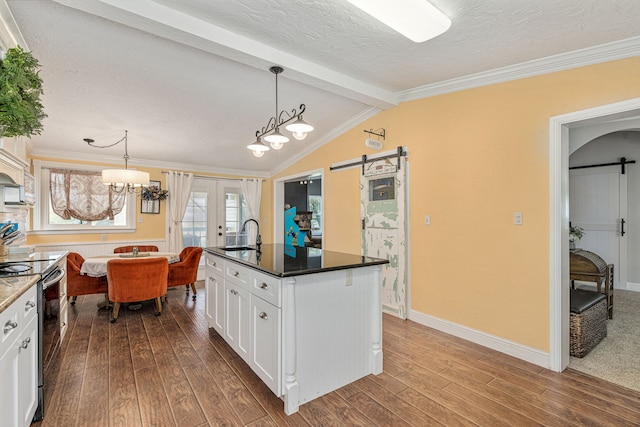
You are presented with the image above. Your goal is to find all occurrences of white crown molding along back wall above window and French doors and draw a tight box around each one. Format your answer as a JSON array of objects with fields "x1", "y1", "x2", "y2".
[{"x1": 29, "y1": 149, "x2": 271, "y2": 179}]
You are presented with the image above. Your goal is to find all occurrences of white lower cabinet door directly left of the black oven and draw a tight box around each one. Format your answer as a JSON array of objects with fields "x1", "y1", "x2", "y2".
[{"x1": 16, "y1": 318, "x2": 38, "y2": 427}]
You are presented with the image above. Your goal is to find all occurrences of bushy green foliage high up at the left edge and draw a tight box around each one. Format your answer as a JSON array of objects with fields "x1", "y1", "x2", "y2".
[{"x1": 0, "y1": 46, "x2": 47, "y2": 137}]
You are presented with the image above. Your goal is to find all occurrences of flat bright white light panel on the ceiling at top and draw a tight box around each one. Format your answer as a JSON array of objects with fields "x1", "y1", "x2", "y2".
[{"x1": 347, "y1": 0, "x2": 451, "y2": 43}]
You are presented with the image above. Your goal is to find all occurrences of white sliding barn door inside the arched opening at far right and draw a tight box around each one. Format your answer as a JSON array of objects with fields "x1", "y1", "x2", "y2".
[{"x1": 569, "y1": 166, "x2": 627, "y2": 288}]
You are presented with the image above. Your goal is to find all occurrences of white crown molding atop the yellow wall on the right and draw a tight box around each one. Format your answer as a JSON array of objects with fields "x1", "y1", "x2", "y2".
[{"x1": 396, "y1": 37, "x2": 640, "y2": 102}]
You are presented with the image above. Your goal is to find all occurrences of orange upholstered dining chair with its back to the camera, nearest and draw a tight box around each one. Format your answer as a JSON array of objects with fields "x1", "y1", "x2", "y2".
[{"x1": 107, "y1": 257, "x2": 169, "y2": 323}]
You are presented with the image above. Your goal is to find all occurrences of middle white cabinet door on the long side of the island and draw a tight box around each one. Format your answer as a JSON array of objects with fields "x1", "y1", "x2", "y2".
[{"x1": 224, "y1": 280, "x2": 251, "y2": 363}]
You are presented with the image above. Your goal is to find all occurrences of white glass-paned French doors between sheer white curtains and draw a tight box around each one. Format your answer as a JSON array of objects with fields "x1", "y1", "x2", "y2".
[{"x1": 182, "y1": 178, "x2": 249, "y2": 279}]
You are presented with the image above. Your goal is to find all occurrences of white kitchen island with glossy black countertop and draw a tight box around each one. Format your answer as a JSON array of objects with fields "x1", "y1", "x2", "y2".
[{"x1": 205, "y1": 244, "x2": 388, "y2": 415}]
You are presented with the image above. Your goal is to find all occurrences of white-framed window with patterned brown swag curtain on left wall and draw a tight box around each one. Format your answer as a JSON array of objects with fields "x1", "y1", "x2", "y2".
[{"x1": 32, "y1": 160, "x2": 136, "y2": 234}]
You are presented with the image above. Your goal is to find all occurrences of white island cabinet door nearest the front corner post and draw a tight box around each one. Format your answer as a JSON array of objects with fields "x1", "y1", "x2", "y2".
[{"x1": 249, "y1": 295, "x2": 282, "y2": 396}]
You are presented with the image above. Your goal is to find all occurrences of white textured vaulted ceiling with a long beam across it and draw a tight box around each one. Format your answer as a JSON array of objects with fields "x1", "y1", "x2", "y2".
[{"x1": 0, "y1": 0, "x2": 640, "y2": 176}]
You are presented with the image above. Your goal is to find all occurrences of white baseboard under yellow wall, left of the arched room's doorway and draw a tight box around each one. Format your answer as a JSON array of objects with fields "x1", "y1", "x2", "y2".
[{"x1": 409, "y1": 310, "x2": 551, "y2": 369}]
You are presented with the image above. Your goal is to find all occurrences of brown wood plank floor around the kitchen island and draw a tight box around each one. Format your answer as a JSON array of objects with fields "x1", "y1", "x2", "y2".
[{"x1": 33, "y1": 289, "x2": 640, "y2": 427}]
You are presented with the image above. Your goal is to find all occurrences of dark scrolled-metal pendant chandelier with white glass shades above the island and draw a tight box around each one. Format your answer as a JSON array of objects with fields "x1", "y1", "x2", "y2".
[{"x1": 247, "y1": 66, "x2": 313, "y2": 157}]
